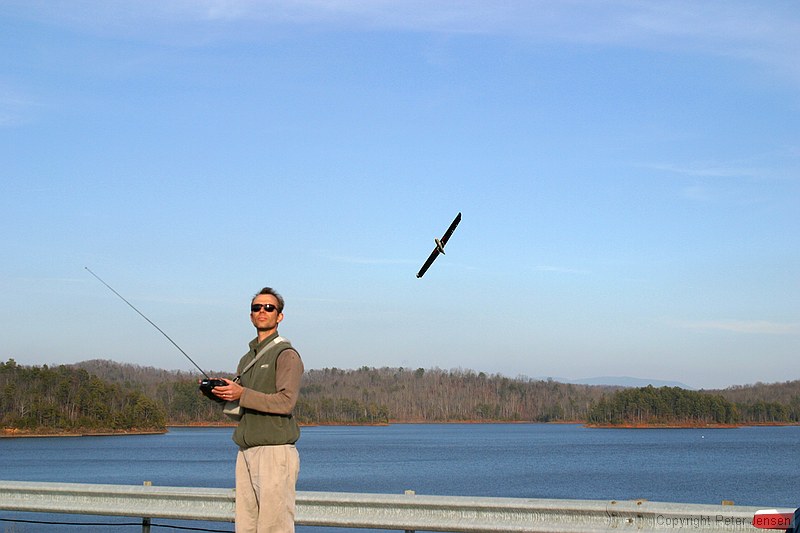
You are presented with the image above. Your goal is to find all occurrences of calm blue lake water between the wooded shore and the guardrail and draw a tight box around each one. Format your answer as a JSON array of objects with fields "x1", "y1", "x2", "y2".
[{"x1": 0, "y1": 424, "x2": 800, "y2": 533}]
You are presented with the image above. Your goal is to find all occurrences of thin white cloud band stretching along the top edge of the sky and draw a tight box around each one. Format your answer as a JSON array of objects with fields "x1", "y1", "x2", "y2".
[{"x1": 9, "y1": 0, "x2": 800, "y2": 84}]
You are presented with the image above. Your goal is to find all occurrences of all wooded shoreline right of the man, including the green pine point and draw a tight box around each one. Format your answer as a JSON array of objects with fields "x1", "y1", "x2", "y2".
[{"x1": 297, "y1": 367, "x2": 800, "y2": 425}]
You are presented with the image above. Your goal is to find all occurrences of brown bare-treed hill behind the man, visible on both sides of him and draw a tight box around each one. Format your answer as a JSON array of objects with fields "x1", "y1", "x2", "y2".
[{"x1": 70, "y1": 360, "x2": 617, "y2": 424}]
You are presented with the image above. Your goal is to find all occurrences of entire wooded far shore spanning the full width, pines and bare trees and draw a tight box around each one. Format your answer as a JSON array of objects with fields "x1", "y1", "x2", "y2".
[{"x1": 0, "y1": 360, "x2": 800, "y2": 431}]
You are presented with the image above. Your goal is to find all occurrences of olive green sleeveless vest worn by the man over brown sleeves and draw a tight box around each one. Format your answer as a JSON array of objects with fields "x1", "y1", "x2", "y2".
[{"x1": 233, "y1": 333, "x2": 300, "y2": 448}]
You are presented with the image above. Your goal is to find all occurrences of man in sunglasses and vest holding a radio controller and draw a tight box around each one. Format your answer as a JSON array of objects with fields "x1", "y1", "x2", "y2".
[{"x1": 213, "y1": 287, "x2": 303, "y2": 533}]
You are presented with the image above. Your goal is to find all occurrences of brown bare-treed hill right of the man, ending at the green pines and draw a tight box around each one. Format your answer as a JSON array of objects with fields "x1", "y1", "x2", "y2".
[{"x1": 298, "y1": 367, "x2": 615, "y2": 423}]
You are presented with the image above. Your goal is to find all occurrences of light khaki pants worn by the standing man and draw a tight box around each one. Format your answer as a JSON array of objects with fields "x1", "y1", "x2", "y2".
[{"x1": 236, "y1": 444, "x2": 300, "y2": 533}]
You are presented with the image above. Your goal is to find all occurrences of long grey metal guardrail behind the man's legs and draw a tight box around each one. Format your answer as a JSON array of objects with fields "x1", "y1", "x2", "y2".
[{"x1": 0, "y1": 481, "x2": 776, "y2": 533}]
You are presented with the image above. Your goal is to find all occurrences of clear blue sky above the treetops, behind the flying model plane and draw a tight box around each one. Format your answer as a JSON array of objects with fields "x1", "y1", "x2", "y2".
[{"x1": 0, "y1": 0, "x2": 800, "y2": 388}]
